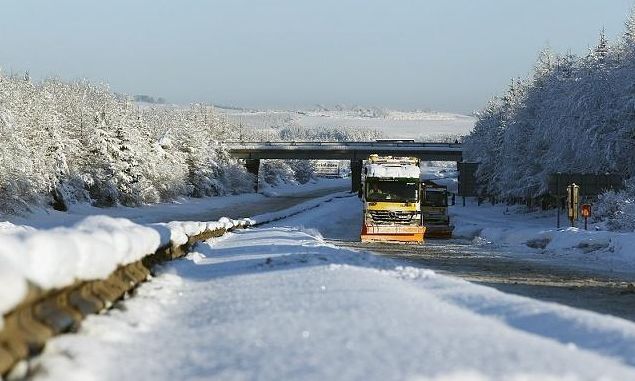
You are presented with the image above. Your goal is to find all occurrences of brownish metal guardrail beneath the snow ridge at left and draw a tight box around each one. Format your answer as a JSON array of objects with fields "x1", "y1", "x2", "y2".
[{"x1": 0, "y1": 221, "x2": 251, "y2": 376}]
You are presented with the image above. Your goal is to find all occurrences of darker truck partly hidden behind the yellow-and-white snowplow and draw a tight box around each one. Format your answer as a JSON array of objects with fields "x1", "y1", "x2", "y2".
[{"x1": 421, "y1": 181, "x2": 454, "y2": 238}]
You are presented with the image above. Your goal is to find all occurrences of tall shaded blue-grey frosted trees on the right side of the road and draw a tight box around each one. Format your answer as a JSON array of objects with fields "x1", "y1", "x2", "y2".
[{"x1": 465, "y1": 9, "x2": 635, "y2": 208}]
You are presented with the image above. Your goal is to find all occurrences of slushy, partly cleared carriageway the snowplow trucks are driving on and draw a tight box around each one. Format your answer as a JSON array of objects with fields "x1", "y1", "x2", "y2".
[{"x1": 279, "y1": 198, "x2": 635, "y2": 321}]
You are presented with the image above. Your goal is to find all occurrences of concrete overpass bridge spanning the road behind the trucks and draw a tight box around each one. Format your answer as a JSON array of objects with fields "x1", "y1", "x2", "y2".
[{"x1": 227, "y1": 141, "x2": 463, "y2": 192}]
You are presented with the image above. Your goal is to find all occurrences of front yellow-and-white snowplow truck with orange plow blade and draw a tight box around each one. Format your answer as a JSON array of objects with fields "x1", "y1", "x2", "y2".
[{"x1": 360, "y1": 155, "x2": 425, "y2": 243}]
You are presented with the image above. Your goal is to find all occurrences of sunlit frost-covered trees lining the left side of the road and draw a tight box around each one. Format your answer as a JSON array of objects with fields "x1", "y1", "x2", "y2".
[{"x1": 0, "y1": 72, "x2": 368, "y2": 213}]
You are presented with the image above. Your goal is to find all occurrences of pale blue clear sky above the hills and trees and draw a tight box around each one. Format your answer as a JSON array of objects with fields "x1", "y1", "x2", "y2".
[{"x1": 0, "y1": 0, "x2": 633, "y2": 113}]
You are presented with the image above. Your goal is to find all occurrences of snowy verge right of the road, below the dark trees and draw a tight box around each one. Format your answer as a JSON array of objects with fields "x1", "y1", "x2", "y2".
[{"x1": 450, "y1": 197, "x2": 635, "y2": 273}]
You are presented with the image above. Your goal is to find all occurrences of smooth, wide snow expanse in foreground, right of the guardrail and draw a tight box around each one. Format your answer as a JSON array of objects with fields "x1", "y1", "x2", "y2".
[{"x1": 28, "y1": 196, "x2": 635, "y2": 381}]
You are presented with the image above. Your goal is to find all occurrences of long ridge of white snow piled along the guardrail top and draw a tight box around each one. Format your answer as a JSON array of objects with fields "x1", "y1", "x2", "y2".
[{"x1": 0, "y1": 192, "x2": 351, "y2": 315}]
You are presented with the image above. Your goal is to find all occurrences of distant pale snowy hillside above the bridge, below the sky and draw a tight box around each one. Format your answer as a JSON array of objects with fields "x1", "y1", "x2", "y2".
[{"x1": 217, "y1": 108, "x2": 476, "y2": 140}]
